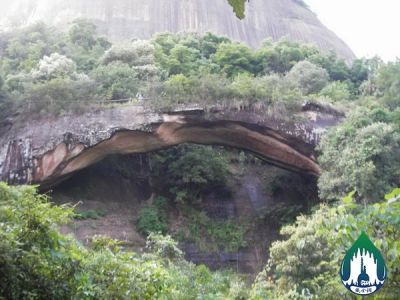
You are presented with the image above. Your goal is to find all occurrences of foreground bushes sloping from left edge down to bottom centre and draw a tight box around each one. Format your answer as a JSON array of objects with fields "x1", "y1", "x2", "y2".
[{"x1": 0, "y1": 183, "x2": 247, "y2": 299}]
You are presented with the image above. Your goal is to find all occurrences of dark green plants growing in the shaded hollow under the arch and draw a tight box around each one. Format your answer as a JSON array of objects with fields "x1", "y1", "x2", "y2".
[{"x1": 142, "y1": 145, "x2": 247, "y2": 252}]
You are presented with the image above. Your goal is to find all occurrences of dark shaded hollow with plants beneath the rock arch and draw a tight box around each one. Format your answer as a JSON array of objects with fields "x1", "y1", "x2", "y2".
[{"x1": 52, "y1": 144, "x2": 318, "y2": 273}]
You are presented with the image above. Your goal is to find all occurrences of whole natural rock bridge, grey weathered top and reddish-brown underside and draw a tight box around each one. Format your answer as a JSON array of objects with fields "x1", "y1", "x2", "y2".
[{"x1": 0, "y1": 105, "x2": 340, "y2": 187}]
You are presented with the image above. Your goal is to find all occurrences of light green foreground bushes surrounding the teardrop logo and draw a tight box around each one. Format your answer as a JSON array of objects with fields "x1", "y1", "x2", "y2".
[{"x1": 251, "y1": 189, "x2": 400, "y2": 299}]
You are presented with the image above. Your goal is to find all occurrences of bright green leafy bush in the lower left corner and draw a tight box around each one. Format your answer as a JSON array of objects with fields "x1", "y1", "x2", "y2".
[{"x1": 0, "y1": 183, "x2": 77, "y2": 299}]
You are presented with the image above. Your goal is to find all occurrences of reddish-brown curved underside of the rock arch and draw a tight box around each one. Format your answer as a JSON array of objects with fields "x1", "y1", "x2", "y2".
[{"x1": 33, "y1": 121, "x2": 320, "y2": 187}]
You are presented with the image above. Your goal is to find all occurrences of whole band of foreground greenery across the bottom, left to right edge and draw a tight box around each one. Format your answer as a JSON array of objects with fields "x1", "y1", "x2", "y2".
[{"x1": 0, "y1": 183, "x2": 400, "y2": 299}]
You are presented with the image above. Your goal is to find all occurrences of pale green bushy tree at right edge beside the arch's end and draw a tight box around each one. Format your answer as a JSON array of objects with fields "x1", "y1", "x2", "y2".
[{"x1": 318, "y1": 108, "x2": 400, "y2": 200}]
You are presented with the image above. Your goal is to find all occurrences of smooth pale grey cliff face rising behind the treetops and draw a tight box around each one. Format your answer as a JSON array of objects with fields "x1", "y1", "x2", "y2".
[{"x1": 0, "y1": 0, "x2": 354, "y2": 61}]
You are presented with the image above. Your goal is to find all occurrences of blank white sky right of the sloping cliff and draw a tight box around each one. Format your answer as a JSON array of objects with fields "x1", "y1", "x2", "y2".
[{"x1": 305, "y1": 0, "x2": 400, "y2": 61}]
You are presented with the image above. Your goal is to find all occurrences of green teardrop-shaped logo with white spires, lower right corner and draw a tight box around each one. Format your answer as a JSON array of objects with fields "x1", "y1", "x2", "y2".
[{"x1": 340, "y1": 232, "x2": 386, "y2": 295}]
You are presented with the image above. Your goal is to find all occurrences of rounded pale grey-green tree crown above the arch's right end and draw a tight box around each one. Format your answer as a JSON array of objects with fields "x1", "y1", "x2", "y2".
[{"x1": 287, "y1": 60, "x2": 329, "y2": 95}]
